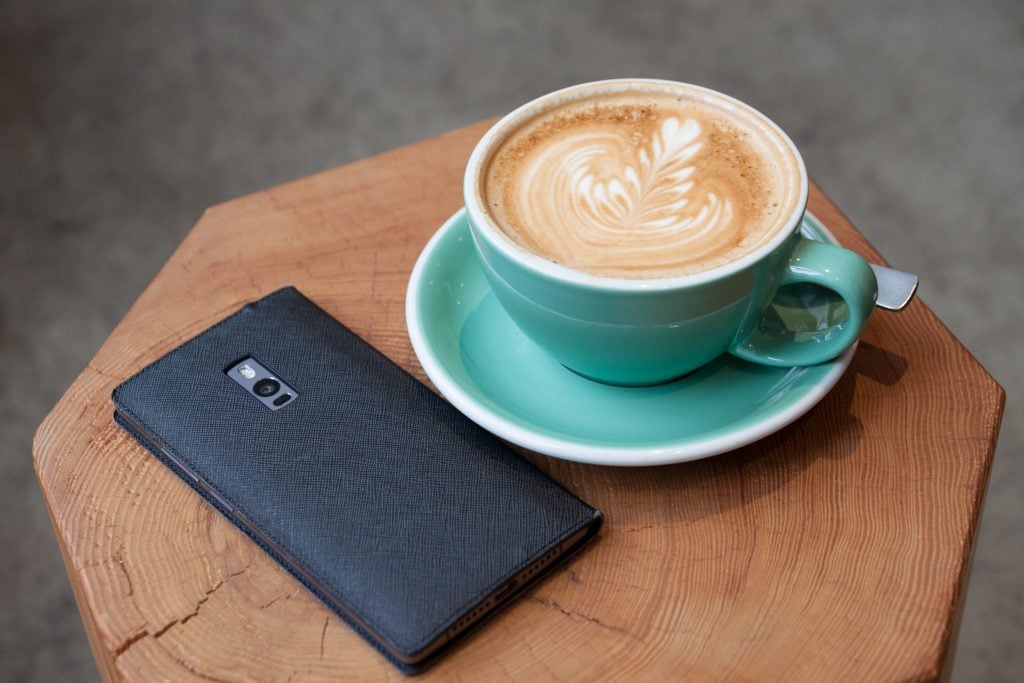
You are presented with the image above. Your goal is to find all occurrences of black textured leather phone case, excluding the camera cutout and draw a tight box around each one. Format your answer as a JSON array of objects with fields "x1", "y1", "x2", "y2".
[{"x1": 113, "y1": 288, "x2": 600, "y2": 672}]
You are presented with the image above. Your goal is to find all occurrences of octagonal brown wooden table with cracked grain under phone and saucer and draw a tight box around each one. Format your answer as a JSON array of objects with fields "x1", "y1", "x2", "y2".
[{"x1": 35, "y1": 122, "x2": 1004, "y2": 681}]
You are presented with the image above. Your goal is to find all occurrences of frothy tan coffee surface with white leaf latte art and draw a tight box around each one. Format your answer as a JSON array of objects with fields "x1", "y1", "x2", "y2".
[{"x1": 479, "y1": 87, "x2": 801, "y2": 279}]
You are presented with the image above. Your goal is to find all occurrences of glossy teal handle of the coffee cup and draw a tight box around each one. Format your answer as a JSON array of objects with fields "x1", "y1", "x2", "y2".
[{"x1": 729, "y1": 238, "x2": 878, "y2": 368}]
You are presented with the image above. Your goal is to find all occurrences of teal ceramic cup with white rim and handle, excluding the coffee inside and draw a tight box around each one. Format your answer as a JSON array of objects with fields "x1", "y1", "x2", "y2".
[{"x1": 464, "y1": 80, "x2": 876, "y2": 386}]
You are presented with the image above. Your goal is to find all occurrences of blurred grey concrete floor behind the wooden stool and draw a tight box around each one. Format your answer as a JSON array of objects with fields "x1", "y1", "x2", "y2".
[{"x1": 0, "y1": 0, "x2": 1024, "y2": 681}]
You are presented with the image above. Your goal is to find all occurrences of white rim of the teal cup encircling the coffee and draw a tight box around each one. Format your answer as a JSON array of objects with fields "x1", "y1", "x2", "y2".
[{"x1": 463, "y1": 78, "x2": 810, "y2": 292}]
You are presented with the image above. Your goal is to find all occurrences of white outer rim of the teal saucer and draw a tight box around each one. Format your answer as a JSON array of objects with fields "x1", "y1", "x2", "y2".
[{"x1": 406, "y1": 207, "x2": 858, "y2": 467}]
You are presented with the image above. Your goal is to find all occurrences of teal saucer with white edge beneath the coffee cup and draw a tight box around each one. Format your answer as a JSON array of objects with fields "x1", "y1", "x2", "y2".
[{"x1": 406, "y1": 210, "x2": 856, "y2": 466}]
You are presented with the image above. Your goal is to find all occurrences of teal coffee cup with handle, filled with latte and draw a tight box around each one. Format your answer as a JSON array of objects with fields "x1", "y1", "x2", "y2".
[{"x1": 464, "y1": 79, "x2": 877, "y2": 386}]
